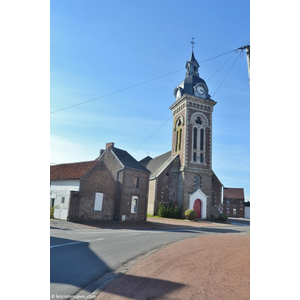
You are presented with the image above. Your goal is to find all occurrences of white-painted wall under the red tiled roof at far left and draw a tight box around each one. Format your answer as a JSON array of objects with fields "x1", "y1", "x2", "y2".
[{"x1": 50, "y1": 180, "x2": 80, "y2": 220}]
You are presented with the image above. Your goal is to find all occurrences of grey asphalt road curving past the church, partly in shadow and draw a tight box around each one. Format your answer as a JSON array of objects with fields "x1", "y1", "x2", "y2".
[{"x1": 50, "y1": 221, "x2": 249, "y2": 299}]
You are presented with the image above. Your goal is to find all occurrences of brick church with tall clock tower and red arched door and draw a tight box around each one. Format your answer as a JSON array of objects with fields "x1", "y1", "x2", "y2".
[{"x1": 140, "y1": 50, "x2": 222, "y2": 219}]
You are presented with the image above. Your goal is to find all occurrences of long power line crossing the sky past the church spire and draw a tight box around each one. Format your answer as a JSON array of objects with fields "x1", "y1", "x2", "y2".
[{"x1": 50, "y1": 49, "x2": 237, "y2": 114}]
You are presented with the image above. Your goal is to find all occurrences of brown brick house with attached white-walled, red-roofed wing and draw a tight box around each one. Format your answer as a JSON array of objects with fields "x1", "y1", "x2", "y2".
[{"x1": 50, "y1": 143, "x2": 150, "y2": 221}]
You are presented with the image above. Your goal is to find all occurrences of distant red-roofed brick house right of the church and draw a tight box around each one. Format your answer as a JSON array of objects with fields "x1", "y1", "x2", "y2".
[{"x1": 223, "y1": 187, "x2": 245, "y2": 218}]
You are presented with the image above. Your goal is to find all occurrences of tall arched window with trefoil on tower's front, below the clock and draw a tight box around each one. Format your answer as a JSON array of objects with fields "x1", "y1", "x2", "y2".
[{"x1": 191, "y1": 114, "x2": 207, "y2": 164}]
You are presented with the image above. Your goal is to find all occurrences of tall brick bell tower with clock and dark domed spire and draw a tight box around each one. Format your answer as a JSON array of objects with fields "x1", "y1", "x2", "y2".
[{"x1": 170, "y1": 42, "x2": 217, "y2": 218}]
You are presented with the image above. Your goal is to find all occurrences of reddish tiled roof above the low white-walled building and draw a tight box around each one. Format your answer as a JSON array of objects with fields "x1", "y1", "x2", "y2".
[{"x1": 50, "y1": 160, "x2": 99, "y2": 181}]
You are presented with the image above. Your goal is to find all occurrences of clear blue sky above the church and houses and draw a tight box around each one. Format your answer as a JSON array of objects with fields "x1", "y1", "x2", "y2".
[{"x1": 50, "y1": 0, "x2": 250, "y2": 200}]
